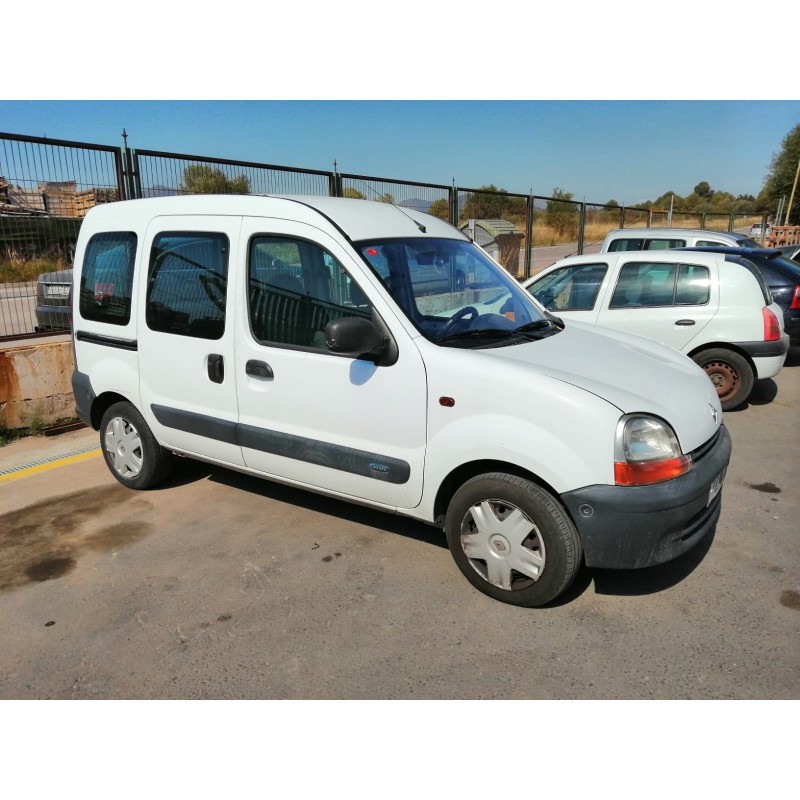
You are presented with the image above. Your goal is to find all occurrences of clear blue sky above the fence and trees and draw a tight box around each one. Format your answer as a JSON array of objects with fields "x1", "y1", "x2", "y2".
[{"x1": 0, "y1": 100, "x2": 800, "y2": 204}]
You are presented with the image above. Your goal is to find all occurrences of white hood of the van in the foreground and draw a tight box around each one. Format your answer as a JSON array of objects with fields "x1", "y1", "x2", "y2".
[{"x1": 492, "y1": 321, "x2": 722, "y2": 453}]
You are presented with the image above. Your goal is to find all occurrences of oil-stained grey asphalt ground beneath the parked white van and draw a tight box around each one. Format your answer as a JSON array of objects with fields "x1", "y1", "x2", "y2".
[{"x1": 0, "y1": 350, "x2": 800, "y2": 700}]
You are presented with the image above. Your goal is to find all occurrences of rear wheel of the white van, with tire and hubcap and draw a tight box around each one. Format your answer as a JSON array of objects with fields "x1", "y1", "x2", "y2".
[{"x1": 100, "y1": 402, "x2": 172, "y2": 489}]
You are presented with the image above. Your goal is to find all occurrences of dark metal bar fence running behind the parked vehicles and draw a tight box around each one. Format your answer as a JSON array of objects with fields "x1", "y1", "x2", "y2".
[{"x1": 0, "y1": 133, "x2": 766, "y2": 342}]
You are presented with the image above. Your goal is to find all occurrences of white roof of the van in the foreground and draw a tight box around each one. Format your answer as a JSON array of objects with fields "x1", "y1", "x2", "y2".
[{"x1": 87, "y1": 194, "x2": 469, "y2": 241}]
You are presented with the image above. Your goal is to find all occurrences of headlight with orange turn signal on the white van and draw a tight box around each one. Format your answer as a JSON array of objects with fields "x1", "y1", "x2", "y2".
[{"x1": 614, "y1": 414, "x2": 692, "y2": 486}]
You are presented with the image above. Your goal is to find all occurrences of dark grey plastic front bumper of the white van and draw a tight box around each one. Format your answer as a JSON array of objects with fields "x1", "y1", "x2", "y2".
[{"x1": 561, "y1": 425, "x2": 731, "y2": 569}]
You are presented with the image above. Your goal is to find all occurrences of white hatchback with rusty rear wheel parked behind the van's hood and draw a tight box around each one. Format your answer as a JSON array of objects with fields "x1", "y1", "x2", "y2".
[{"x1": 523, "y1": 250, "x2": 789, "y2": 411}]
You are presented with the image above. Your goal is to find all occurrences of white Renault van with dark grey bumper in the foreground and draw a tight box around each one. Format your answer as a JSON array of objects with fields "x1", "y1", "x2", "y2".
[{"x1": 73, "y1": 195, "x2": 731, "y2": 606}]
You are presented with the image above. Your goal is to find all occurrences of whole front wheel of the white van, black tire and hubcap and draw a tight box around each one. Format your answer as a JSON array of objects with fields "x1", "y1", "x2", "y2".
[{"x1": 445, "y1": 472, "x2": 583, "y2": 608}]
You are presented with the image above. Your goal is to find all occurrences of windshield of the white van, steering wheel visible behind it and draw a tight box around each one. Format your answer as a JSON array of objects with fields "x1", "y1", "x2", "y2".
[{"x1": 356, "y1": 238, "x2": 563, "y2": 347}]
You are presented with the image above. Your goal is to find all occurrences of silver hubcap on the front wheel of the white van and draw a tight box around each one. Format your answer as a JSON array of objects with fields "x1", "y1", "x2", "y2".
[{"x1": 461, "y1": 500, "x2": 545, "y2": 591}]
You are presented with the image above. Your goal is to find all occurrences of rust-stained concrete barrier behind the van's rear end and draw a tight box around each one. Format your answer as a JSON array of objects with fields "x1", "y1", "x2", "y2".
[{"x1": 0, "y1": 335, "x2": 75, "y2": 430}]
